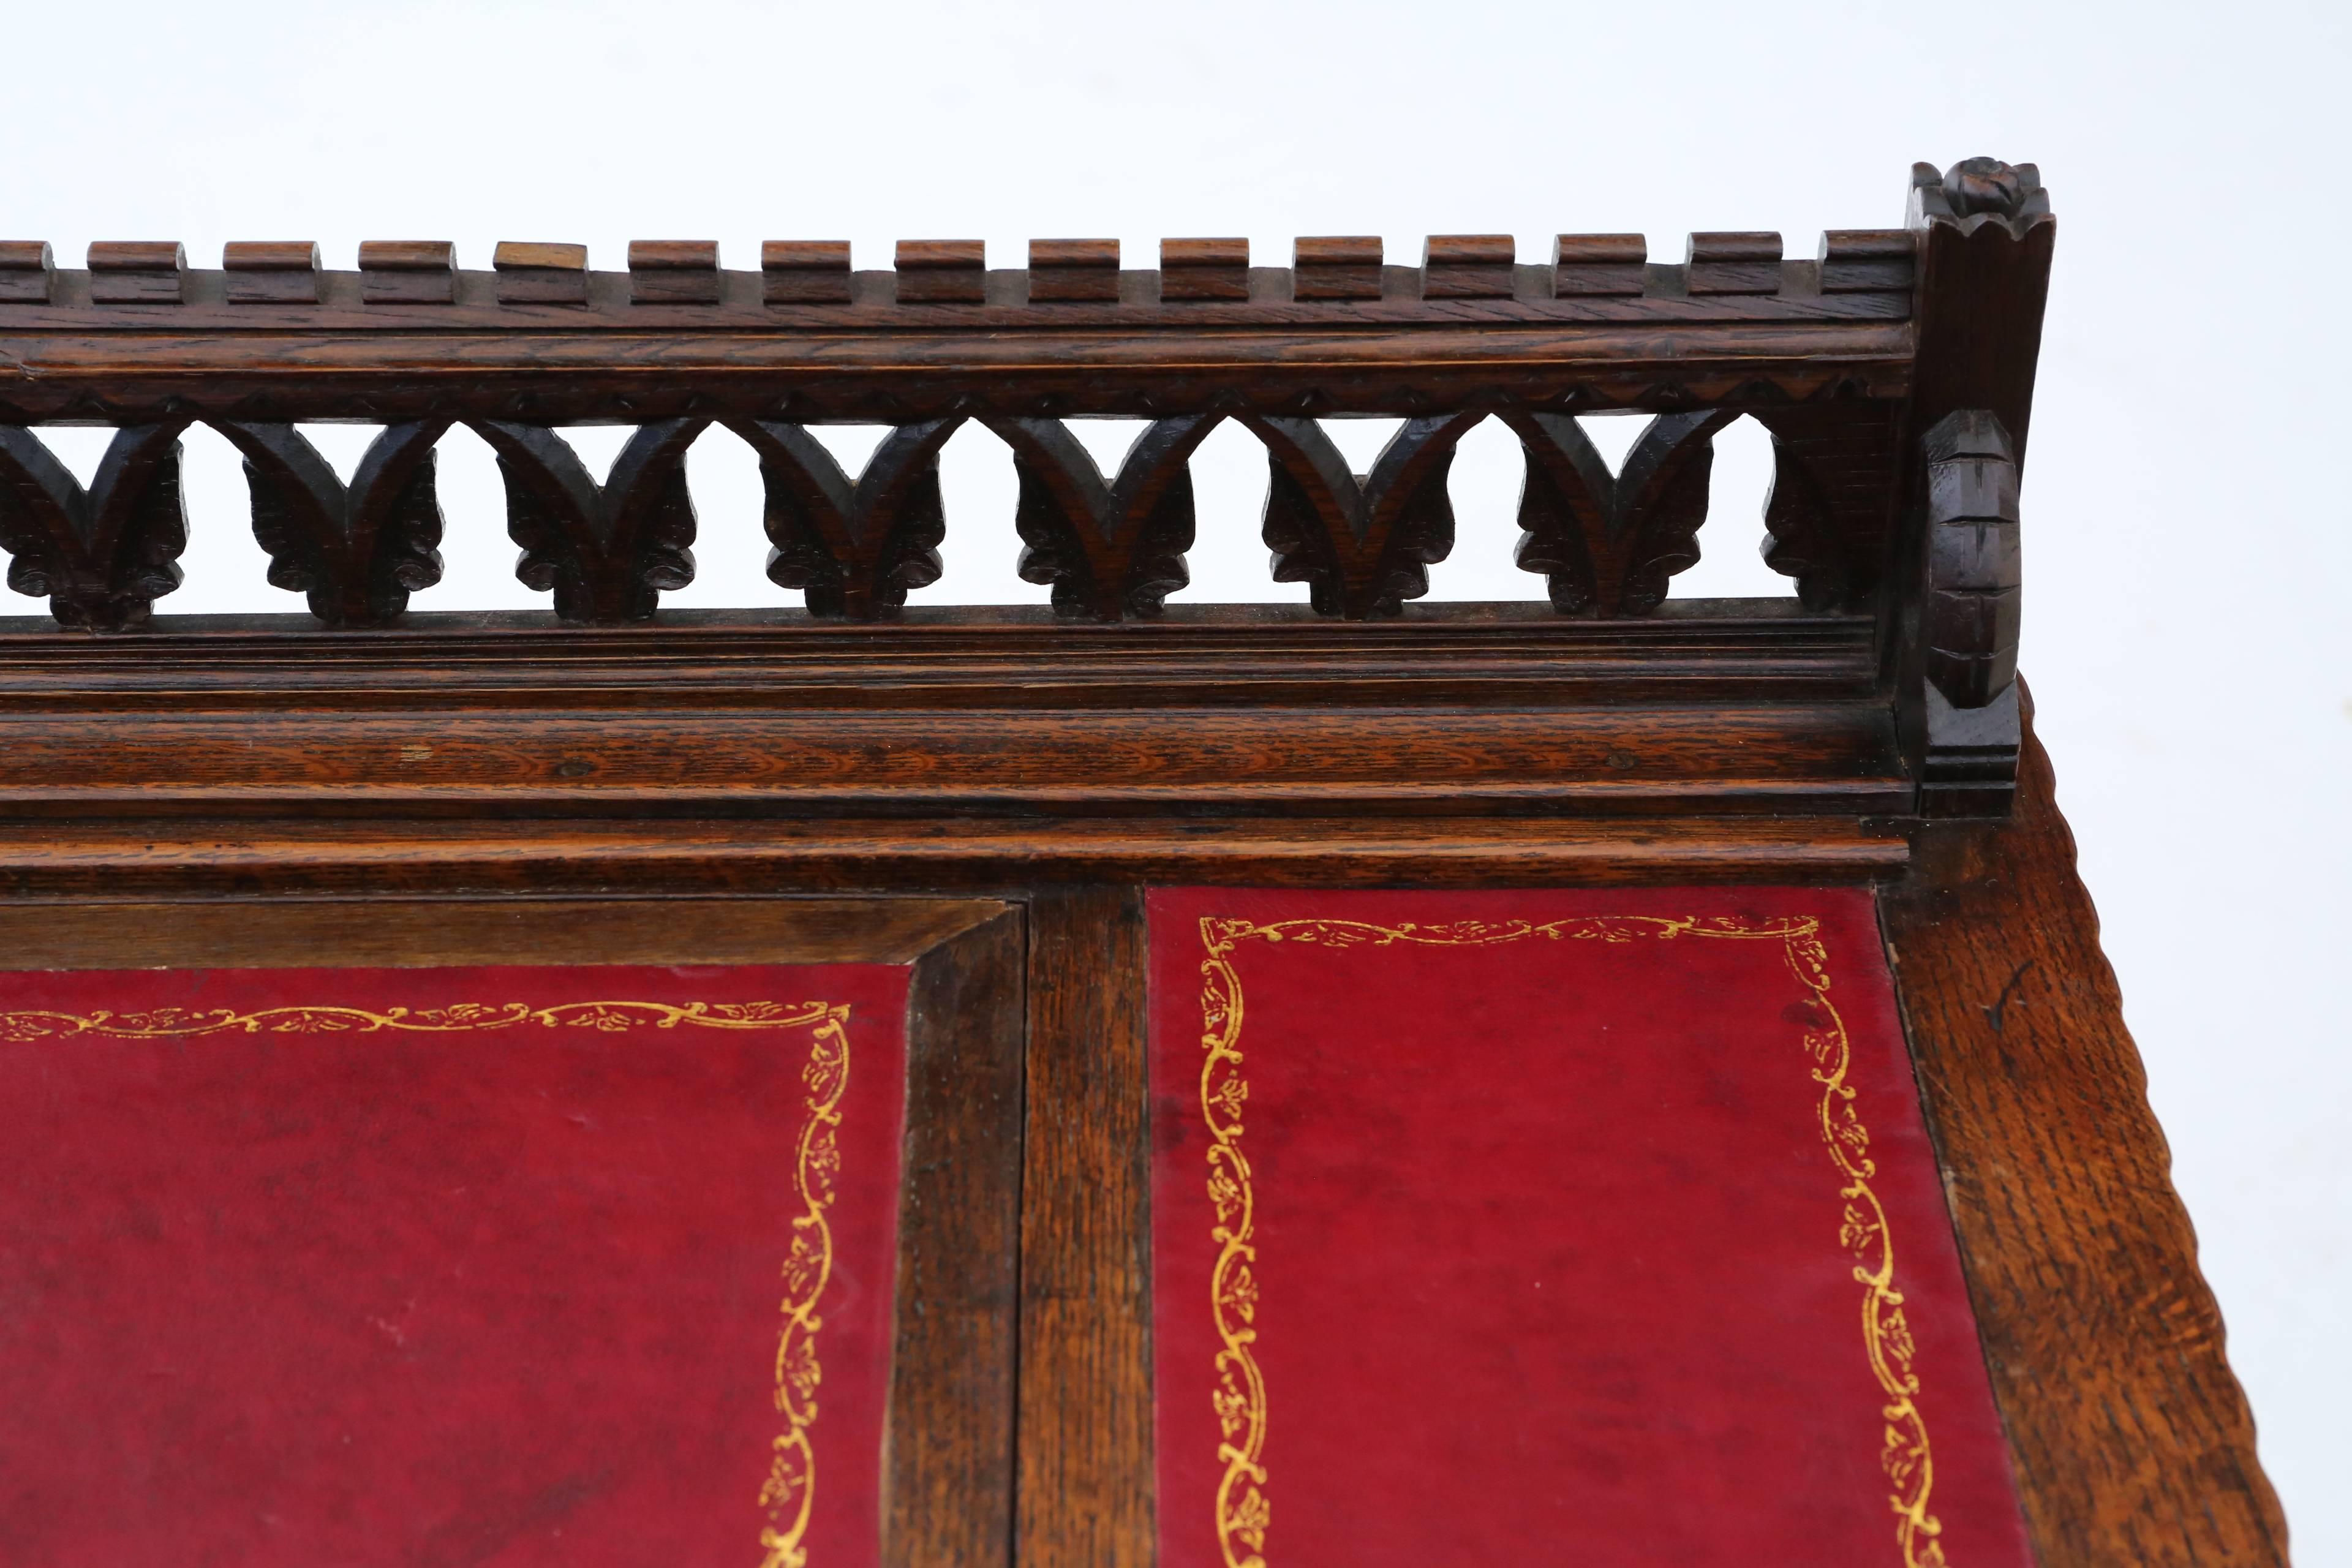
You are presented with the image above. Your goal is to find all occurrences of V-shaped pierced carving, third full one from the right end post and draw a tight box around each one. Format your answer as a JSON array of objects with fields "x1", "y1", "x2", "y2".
[{"x1": 988, "y1": 414, "x2": 1218, "y2": 620}]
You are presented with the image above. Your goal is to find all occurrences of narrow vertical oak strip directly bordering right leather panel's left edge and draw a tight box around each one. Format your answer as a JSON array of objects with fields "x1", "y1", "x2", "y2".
[{"x1": 1016, "y1": 886, "x2": 1155, "y2": 1568}]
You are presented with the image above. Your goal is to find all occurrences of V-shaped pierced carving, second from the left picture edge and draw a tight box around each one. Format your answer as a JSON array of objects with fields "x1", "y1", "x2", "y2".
[{"x1": 219, "y1": 421, "x2": 449, "y2": 625}]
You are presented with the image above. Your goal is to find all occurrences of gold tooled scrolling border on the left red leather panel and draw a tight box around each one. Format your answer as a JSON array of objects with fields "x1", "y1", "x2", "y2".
[{"x1": 0, "y1": 1001, "x2": 849, "y2": 1568}]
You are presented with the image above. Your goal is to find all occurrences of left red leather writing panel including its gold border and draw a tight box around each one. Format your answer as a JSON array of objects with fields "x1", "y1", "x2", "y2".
[{"x1": 0, "y1": 966, "x2": 905, "y2": 1568}]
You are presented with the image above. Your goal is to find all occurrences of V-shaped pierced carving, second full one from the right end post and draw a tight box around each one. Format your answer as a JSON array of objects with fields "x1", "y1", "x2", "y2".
[{"x1": 1242, "y1": 414, "x2": 1484, "y2": 620}]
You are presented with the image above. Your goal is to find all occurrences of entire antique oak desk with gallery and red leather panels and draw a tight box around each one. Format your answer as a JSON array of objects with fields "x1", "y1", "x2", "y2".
[{"x1": 0, "y1": 160, "x2": 2284, "y2": 1568}]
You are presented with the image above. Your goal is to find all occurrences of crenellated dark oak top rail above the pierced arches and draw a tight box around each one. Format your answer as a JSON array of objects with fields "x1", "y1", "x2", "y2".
[{"x1": 0, "y1": 230, "x2": 1912, "y2": 423}]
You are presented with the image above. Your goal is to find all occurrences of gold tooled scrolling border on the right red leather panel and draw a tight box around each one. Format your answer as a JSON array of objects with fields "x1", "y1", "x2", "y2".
[{"x1": 1199, "y1": 914, "x2": 1948, "y2": 1568}]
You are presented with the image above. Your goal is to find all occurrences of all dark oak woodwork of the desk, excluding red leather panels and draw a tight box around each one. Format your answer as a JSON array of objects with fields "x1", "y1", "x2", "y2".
[{"x1": 0, "y1": 157, "x2": 2284, "y2": 1568}]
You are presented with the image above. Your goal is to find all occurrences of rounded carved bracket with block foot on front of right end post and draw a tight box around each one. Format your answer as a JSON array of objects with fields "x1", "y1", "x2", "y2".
[{"x1": 1919, "y1": 409, "x2": 2022, "y2": 816}]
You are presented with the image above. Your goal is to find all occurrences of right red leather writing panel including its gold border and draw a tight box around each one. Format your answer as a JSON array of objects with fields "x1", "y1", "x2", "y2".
[{"x1": 1150, "y1": 889, "x2": 2030, "y2": 1568}]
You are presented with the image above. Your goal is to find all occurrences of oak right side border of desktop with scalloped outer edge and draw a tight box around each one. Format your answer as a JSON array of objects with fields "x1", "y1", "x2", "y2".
[{"x1": 1879, "y1": 705, "x2": 2286, "y2": 1568}]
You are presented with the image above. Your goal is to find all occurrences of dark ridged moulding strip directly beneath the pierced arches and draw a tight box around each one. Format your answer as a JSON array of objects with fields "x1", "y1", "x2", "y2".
[{"x1": 0, "y1": 600, "x2": 1877, "y2": 712}]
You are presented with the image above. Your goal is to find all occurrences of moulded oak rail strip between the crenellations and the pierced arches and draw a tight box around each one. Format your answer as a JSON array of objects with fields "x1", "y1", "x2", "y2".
[{"x1": 0, "y1": 310, "x2": 1912, "y2": 423}]
